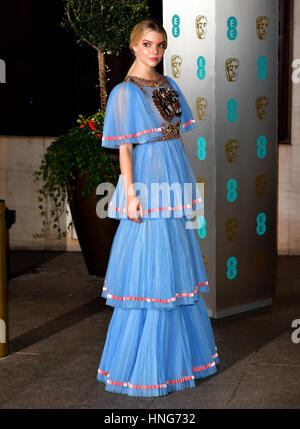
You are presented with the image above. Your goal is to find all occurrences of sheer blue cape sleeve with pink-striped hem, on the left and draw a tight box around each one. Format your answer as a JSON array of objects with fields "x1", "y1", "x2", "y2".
[{"x1": 102, "y1": 82, "x2": 163, "y2": 149}]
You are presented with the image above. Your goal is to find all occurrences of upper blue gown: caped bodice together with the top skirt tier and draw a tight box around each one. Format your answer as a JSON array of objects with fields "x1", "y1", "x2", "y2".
[{"x1": 102, "y1": 75, "x2": 202, "y2": 219}]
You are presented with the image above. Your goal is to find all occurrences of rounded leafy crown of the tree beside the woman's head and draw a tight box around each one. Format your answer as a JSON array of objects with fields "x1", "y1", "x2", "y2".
[{"x1": 61, "y1": 0, "x2": 149, "y2": 55}]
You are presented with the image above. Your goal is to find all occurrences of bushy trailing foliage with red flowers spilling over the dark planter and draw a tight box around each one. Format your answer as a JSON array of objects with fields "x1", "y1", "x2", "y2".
[{"x1": 33, "y1": 111, "x2": 120, "y2": 239}]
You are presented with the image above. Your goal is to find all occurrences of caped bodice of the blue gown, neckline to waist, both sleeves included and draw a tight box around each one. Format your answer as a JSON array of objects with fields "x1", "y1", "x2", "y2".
[{"x1": 102, "y1": 75, "x2": 196, "y2": 149}]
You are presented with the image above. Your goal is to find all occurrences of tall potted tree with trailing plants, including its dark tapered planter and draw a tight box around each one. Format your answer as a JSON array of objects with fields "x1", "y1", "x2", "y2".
[{"x1": 33, "y1": 0, "x2": 149, "y2": 277}]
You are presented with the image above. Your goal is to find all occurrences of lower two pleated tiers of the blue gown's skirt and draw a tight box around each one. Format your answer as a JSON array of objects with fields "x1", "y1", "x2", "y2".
[{"x1": 97, "y1": 217, "x2": 219, "y2": 397}]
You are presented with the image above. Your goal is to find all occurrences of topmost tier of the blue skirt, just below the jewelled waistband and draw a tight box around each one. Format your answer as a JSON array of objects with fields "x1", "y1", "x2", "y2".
[{"x1": 108, "y1": 138, "x2": 204, "y2": 219}]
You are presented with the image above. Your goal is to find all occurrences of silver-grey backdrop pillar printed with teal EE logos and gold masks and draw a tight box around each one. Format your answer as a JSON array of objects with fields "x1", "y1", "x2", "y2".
[{"x1": 163, "y1": 0, "x2": 278, "y2": 318}]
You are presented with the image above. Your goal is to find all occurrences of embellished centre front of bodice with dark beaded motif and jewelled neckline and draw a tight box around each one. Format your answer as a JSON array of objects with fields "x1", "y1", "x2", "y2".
[{"x1": 124, "y1": 75, "x2": 182, "y2": 141}]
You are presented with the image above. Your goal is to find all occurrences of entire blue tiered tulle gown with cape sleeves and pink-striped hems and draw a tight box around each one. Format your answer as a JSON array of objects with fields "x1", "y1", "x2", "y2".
[{"x1": 97, "y1": 72, "x2": 219, "y2": 397}]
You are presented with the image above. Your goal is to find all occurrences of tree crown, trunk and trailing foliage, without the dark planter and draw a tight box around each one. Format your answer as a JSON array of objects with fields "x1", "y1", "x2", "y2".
[{"x1": 33, "y1": 0, "x2": 149, "y2": 238}]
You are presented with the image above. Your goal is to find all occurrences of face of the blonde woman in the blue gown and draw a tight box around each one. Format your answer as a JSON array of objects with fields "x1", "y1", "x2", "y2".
[{"x1": 132, "y1": 31, "x2": 166, "y2": 67}]
